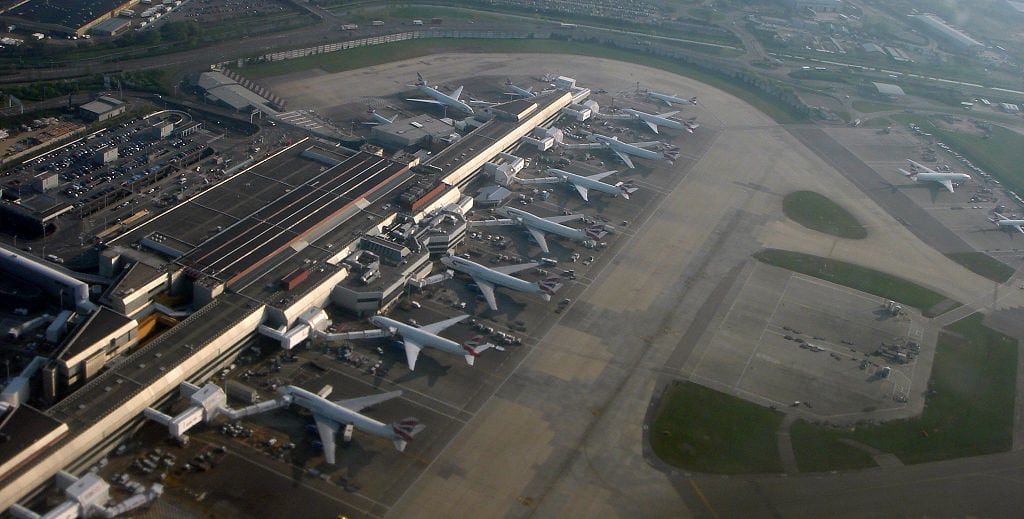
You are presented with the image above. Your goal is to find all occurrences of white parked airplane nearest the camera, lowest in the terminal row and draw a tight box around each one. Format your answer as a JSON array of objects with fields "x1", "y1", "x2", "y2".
[{"x1": 278, "y1": 386, "x2": 424, "y2": 465}]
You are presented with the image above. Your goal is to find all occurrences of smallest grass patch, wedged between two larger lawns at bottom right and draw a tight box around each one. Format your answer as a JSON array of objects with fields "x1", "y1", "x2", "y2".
[{"x1": 790, "y1": 420, "x2": 876, "y2": 472}]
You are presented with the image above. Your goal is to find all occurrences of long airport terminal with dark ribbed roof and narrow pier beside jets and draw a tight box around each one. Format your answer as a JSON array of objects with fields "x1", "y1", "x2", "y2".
[{"x1": 0, "y1": 88, "x2": 577, "y2": 509}]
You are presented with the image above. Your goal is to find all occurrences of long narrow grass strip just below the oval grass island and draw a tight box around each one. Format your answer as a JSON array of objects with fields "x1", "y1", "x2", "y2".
[{"x1": 754, "y1": 249, "x2": 959, "y2": 315}]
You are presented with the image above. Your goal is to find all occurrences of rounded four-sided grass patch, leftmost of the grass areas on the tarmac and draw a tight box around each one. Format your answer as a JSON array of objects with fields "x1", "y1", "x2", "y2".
[{"x1": 650, "y1": 382, "x2": 782, "y2": 474}]
